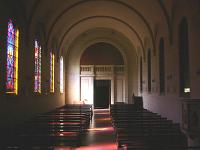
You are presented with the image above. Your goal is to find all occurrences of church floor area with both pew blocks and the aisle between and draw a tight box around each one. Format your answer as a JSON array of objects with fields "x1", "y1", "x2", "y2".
[{"x1": 1, "y1": 103, "x2": 199, "y2": 150}]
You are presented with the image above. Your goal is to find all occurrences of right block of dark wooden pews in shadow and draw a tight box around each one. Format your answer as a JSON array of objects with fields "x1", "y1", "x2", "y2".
[{"x1": 111, "y1": 104, "x2": 187, "y2": 150}]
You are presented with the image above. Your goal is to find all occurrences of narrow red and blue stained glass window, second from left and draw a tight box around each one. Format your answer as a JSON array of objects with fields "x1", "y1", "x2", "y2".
[{"x1": 34, "y1": 40, "x2": 41, "y2": 93}]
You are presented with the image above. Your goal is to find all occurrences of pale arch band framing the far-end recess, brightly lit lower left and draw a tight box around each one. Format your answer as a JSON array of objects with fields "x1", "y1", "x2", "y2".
[{"x1": 64, "y1": 29, "x2": 138, "y2": 103}]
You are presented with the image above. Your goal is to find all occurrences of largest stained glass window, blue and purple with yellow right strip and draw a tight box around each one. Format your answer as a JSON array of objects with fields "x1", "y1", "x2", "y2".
[{"x1": 6, "y1": 20, "x2": 19, "y2": 95}]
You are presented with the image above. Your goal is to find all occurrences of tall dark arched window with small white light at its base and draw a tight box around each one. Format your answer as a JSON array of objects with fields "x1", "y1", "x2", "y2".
[{"x1": 179, "y1": 18, "x2": 190, "y2": 96}]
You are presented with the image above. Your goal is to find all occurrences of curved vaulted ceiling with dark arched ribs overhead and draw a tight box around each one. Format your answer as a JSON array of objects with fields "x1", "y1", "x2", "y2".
[{"x1": 14, "y1": 0, "x2": 173, "y2": 56}]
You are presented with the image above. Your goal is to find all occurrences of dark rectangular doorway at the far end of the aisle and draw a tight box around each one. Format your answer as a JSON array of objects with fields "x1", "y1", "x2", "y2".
[{"x1": 94, "y1": 80, "x2": 111, "y2": 109}]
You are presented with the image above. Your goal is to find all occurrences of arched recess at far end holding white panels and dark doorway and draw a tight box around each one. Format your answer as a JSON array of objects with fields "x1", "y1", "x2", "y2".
[{"x1": 80, "y1": 42, "x2": 125, "y2": 108}]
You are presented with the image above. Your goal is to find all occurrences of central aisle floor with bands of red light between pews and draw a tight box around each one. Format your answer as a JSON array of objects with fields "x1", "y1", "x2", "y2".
[{"x1": 76, "y1": 109, "x2": 117, "y2": 150}]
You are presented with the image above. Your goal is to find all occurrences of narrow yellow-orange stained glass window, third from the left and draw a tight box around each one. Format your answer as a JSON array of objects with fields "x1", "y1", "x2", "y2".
[{"x1": 50, "y1": 52, "x2": 54, "y2": 93}]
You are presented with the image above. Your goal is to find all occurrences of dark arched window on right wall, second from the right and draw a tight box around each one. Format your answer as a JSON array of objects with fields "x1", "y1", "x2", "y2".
[{"x1": 159, "y1": 38, "x2": 165, "y2": 94}]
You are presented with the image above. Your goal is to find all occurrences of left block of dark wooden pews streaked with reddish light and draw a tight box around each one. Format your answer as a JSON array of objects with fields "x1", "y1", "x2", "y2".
[{"x1": 4, "y1": 104, "x2": 92, "y2": 149}]
